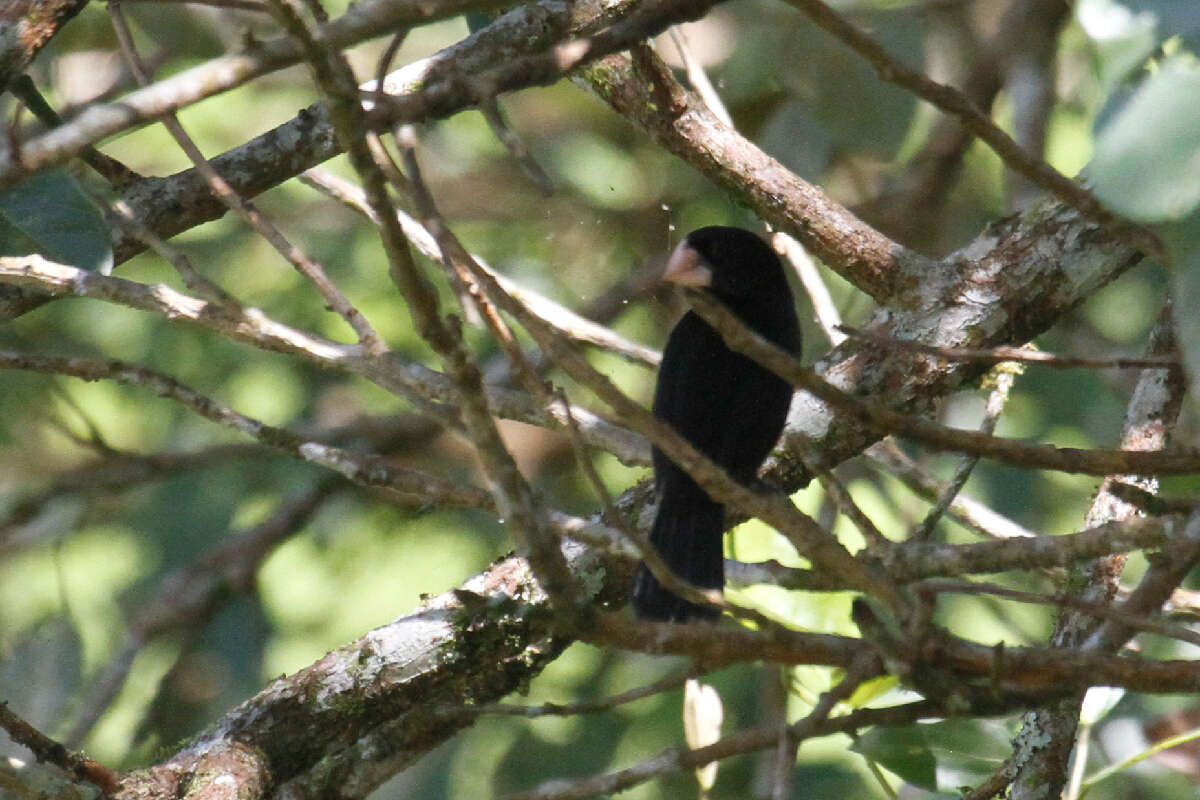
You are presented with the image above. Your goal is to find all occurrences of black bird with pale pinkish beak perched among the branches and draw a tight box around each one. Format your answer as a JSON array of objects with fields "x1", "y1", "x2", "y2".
[{"x1": 634, "y1": 227, "x2": 800, "y2": 622}]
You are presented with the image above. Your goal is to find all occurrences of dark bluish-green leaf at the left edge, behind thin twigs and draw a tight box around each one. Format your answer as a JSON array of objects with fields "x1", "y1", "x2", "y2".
[{"x1": 0, "y1": 169, "x2": 113, "y2": 275}]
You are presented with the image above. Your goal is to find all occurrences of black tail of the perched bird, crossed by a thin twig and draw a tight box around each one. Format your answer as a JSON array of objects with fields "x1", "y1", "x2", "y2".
[{"x1": 634, "y1": 495, "x2": 725, "y2": 622}]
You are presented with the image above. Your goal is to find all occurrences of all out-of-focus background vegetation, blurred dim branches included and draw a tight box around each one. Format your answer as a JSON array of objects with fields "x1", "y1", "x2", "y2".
[{"x1": 0, "y1": 0, "x2": 1200, "y2": 799}]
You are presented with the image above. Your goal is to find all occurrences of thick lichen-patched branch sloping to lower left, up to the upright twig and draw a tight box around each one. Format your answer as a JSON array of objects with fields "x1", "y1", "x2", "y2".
[{"x1": 116, "y1": 547, "x2": 590, "y2": 800}]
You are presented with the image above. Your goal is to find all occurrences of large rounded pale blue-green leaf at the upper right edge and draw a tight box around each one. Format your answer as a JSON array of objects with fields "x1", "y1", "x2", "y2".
[{"x1": 1086, "y1": 58, "x2": 1200, "y2": 222}]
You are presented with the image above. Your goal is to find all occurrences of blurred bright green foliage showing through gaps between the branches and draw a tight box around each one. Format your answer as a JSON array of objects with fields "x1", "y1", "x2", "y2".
[{"x1": 0, "y1": 0, "x2": 1200, "y2": 800}]
